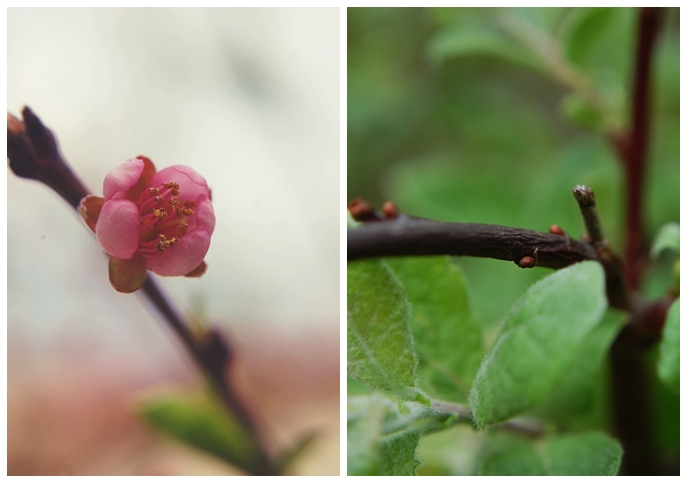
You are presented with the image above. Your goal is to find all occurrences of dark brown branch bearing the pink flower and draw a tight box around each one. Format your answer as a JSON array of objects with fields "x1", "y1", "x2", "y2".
[{"x1": 7, "y1": 107, "x2": 274, "y2": 475}]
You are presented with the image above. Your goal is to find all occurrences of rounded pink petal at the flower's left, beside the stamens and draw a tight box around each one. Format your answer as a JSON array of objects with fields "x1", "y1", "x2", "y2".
[{"x1": 95, "y1": 199, "x2": 141, "y2": 260}]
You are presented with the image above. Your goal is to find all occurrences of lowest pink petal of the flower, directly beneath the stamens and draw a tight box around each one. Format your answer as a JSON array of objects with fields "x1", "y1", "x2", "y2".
[{"x1": 147, "y1": 230, "x2": 210, "y2": 277}]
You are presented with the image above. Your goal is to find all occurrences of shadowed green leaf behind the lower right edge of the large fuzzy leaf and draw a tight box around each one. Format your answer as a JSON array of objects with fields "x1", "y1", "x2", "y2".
[{"x1": 536, "y1": 309, "x2": 627, "y2": 422}]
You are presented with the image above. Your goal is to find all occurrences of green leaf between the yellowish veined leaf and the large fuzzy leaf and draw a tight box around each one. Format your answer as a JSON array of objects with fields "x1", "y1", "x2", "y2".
[{"x1": 387, "y1": 257, "x2": 484, "y2": 401}]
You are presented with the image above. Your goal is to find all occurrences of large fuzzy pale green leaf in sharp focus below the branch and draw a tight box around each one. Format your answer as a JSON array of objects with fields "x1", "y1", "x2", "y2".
[{"x1": 469, "y1": 262, "x2": 607, "y2": 428}]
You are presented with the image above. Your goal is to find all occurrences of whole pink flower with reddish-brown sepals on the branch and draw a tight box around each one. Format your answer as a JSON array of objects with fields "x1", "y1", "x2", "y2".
[{"x1": 79, "y1": 156, "x2": 215, "y2": 293}]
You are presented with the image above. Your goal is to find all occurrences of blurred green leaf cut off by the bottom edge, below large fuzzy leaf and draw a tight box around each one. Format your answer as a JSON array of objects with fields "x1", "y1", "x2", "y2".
[{"x1": 480, "y1": 432, "x2": 623, "y2": 476}]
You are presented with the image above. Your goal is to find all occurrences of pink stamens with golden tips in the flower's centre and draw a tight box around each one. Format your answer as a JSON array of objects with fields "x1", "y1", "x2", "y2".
[{"x1": 137, "y1": 182, "x2": 196, "y2": 259}]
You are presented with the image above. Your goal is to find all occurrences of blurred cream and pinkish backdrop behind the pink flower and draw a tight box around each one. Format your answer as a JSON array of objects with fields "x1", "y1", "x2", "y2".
[{"x1": 7, "y1": 8, "x2": 340, "y2": 475}]
